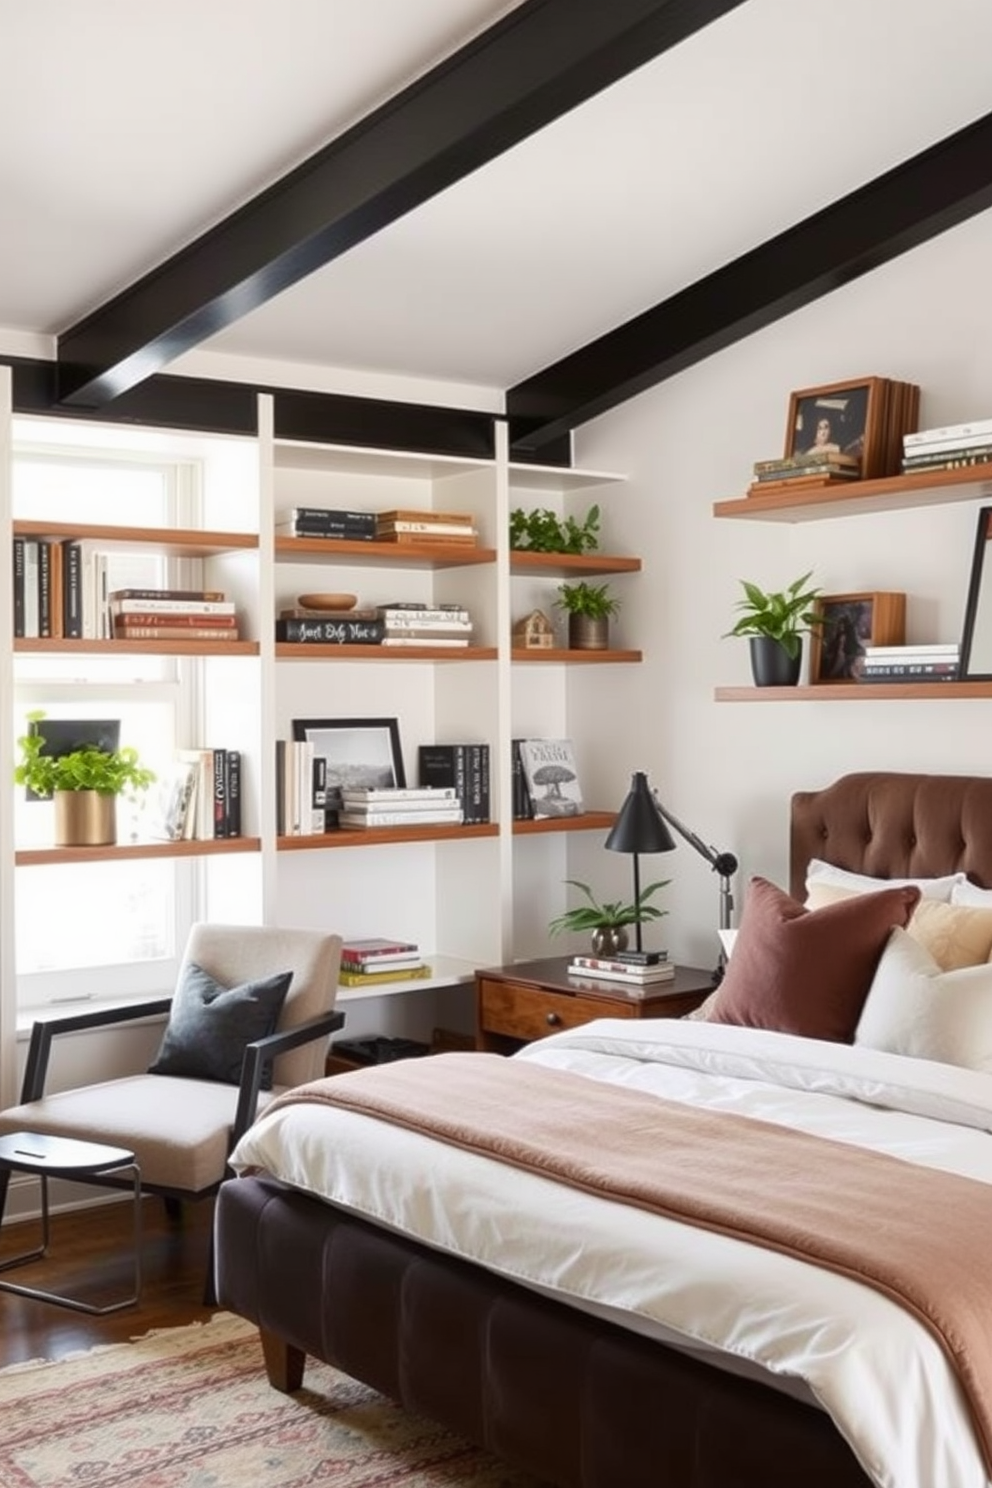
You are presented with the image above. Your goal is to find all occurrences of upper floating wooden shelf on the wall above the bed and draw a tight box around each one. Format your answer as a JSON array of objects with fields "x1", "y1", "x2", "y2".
[{"x1": 712, "y1": 463, "x2": 992, "y2": 522}]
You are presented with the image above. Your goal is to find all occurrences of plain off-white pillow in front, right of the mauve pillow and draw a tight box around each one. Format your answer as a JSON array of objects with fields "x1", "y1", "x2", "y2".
[{"x1": 854, "y1": 929, "x2": 992, "y2": 1073}]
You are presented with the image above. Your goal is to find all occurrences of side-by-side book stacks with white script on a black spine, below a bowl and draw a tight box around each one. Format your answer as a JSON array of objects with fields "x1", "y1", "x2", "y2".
[{"x1": 275, "y1": 604, "x2": 473, "y2": 647}]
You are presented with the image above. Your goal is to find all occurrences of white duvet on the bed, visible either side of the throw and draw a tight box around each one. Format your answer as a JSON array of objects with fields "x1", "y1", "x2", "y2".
[{"x1": 232, "y1": 1019, "x2": 992, "y2": 1488}]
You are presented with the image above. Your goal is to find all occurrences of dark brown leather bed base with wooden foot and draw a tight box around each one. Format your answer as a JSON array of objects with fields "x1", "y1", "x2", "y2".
[{"x1": 216, "y1": 1177, "x2": 869, "y2": 1488}]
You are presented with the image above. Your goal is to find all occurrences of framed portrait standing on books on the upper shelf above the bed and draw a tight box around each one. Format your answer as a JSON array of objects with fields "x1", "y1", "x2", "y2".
[{"x1": 785, "y1": 376, "x2": 886, "y2": 479}]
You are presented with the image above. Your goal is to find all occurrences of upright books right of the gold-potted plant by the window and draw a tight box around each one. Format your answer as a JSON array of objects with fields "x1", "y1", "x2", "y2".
[{"x1": 147, "y1": 748, "x2": 241, "y2": 842}]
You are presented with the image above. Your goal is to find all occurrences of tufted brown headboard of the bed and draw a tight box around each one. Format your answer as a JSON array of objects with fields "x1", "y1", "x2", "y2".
[{"x1": 790, "y1": 771, "x2": 992, "y2": 900}]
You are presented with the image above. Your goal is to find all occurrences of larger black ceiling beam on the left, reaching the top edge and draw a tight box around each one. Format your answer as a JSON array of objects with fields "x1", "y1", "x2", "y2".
[{"x1": 58, "y1": 0, "x2": 744, "y2": 408}]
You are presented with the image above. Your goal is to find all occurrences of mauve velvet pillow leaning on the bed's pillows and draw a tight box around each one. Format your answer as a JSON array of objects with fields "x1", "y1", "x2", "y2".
[{"x1": 706, "y1": 878, "x2": 919, "y2": 1043}]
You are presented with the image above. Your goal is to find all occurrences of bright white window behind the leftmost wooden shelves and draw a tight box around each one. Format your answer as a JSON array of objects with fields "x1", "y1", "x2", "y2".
[{"x1": 12, "y1": 432, "x2": 199, "y2": 1009}]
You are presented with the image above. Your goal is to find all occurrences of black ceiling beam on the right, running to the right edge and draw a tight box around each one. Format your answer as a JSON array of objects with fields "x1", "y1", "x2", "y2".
[{"x1": 506, "y1": 115, "x2": 992, "y2": 457}]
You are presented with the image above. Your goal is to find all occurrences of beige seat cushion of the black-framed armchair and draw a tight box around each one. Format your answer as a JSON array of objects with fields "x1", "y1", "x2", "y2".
[{"x1": 0, "y1": 1074, "x2": 278, "y2": 1196}]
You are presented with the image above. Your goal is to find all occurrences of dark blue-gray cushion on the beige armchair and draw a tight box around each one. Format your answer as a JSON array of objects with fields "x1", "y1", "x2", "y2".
[{"x1": 149, "y1": 961, "x2": 293, "y2": 1088}]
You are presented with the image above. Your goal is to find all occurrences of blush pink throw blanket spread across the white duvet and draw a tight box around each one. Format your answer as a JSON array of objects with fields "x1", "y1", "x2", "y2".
[{"x1": 265, "y1": 1054, "x2": 992, "y2": 1467}]
